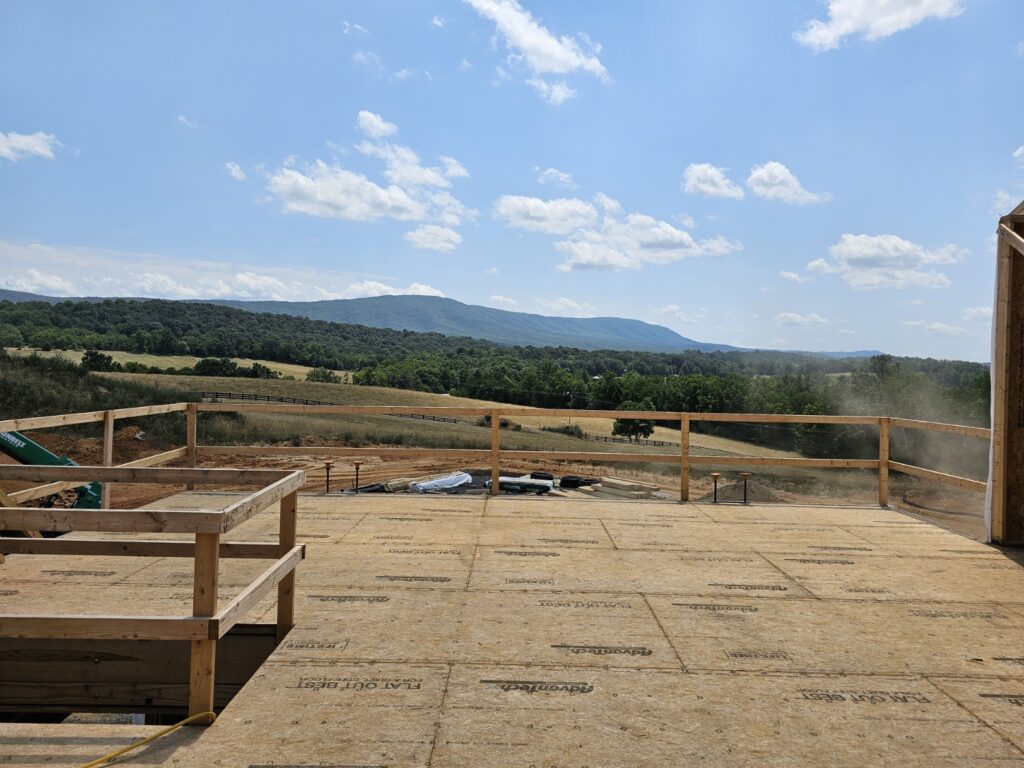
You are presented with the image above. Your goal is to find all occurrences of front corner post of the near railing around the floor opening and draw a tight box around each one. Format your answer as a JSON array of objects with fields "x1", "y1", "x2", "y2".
[{"x1": 188, "y1": 534, "x2": 220, "y2": 725}]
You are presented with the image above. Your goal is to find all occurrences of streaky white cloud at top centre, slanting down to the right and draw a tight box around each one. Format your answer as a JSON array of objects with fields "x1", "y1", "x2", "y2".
[{"x1": 466, "y1": 0, "x2": 608, "y2": 104}]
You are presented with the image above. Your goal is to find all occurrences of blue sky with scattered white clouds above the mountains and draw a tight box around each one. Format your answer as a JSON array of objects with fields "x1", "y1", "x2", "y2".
[{"x1": 0, "y1": 0, "x2": 1024, "y2": 359}]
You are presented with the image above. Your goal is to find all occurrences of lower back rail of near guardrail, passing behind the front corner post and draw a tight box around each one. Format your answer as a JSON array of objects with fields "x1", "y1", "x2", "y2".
[{"x1": 0, "y1": 538, "x2": 288, "y2": 559}]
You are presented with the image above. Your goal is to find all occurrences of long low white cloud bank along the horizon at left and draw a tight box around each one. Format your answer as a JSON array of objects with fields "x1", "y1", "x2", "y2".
[{"x1": 0, "y1": 241, "x2": 444, "y2": 301}]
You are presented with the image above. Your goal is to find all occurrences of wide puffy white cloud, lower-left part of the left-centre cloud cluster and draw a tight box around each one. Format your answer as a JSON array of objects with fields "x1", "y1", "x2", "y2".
[{"x1": 268, "y1": 160, "x2": 427, "y2": 221}]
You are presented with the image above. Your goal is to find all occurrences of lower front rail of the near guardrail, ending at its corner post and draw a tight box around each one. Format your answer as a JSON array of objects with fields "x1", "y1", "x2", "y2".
[{"x1": 0, "y1": 614, "x2": 217, "y2": 641}]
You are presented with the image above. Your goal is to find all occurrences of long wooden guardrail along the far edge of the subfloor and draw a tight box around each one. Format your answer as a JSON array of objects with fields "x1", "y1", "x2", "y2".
[{"x1": 0, "y1": 403, "x2": 991, "y2": 506}]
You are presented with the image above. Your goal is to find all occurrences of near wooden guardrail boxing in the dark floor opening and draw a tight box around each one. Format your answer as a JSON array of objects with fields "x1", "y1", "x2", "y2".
[{"x1": 0, "y1": 465, "x2": 305, "y2": 716}]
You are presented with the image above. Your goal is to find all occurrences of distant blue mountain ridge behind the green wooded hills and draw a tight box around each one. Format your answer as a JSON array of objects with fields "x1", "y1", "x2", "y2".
[{"x1": 0, "y1": 289, "x2": 878, "y2": 357}]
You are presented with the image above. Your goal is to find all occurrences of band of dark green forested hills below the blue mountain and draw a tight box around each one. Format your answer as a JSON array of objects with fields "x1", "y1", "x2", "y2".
[{"x1": 0, "y1": 300, "x2": 989, "y2": 438}]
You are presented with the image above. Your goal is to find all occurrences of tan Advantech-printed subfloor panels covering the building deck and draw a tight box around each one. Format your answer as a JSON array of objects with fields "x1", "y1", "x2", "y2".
[{"x1": 0, "y1": 495, "x2": 1024, "y2": 768}]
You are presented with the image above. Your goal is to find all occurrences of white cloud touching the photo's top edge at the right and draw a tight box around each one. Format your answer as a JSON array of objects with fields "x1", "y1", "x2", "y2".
[{"x1": 794, "y1": 0, "x2": 964, "y2": 51}]
